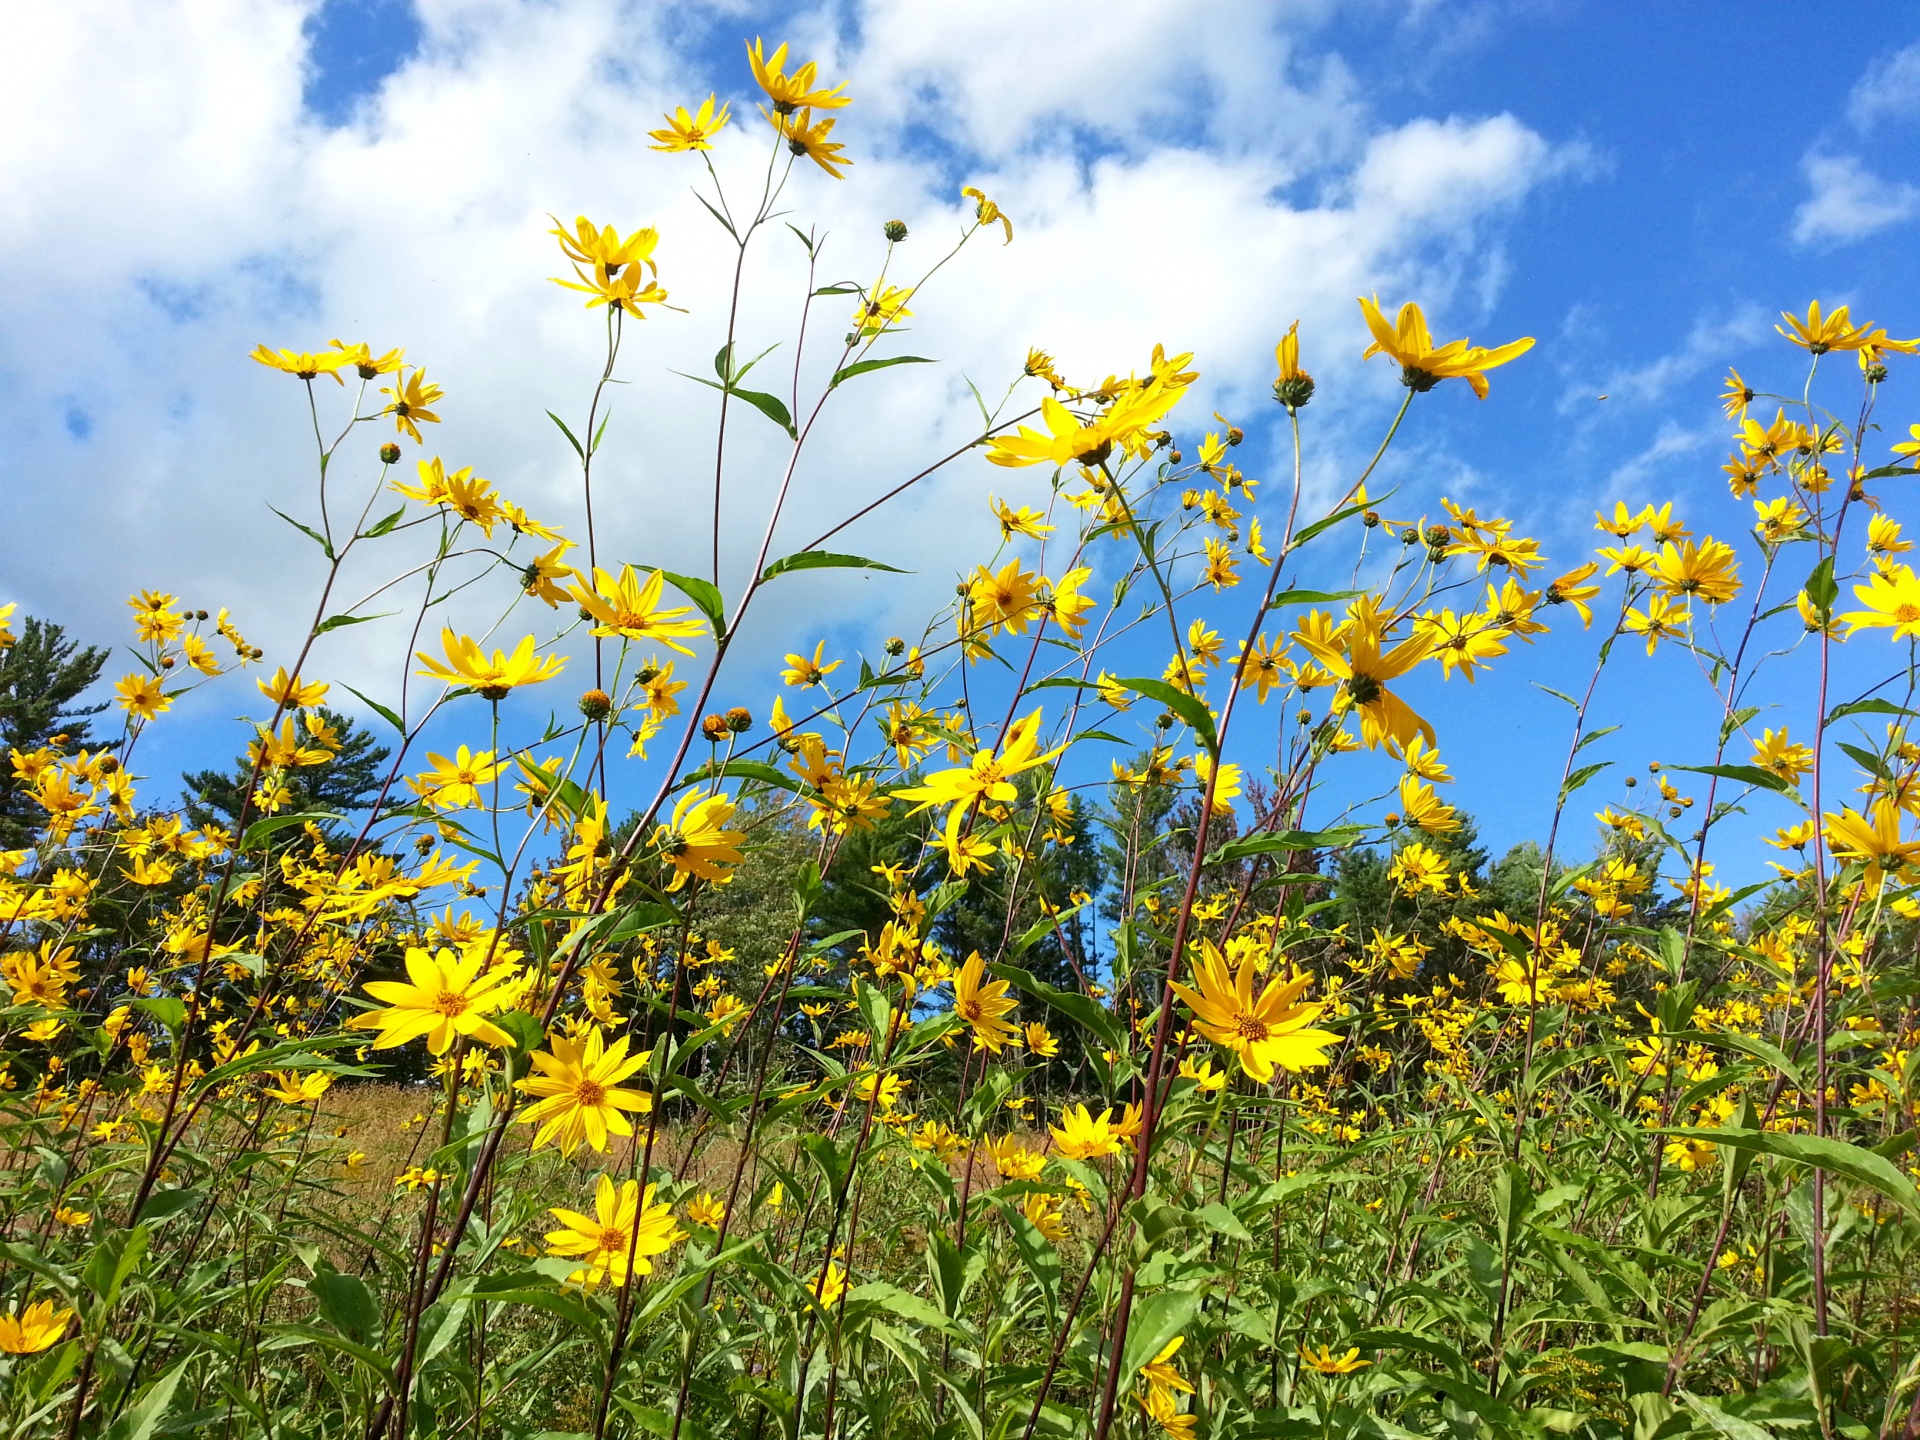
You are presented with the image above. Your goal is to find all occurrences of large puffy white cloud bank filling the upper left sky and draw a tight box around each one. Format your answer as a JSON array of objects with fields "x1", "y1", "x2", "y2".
[{"x1": 0, "y1": 0, "x2": 1578, "y2": 725}]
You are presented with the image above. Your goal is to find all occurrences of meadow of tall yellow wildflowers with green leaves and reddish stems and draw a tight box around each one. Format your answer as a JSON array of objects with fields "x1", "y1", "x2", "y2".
[{"x1": 0, "y1": 33, "x2": 1920, "y2": 1440}]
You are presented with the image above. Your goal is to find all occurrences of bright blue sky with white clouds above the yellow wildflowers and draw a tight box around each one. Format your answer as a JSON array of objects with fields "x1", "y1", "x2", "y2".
[{"x1": 0, "y1": 0, "x2": 1920, "y2": 890}]
